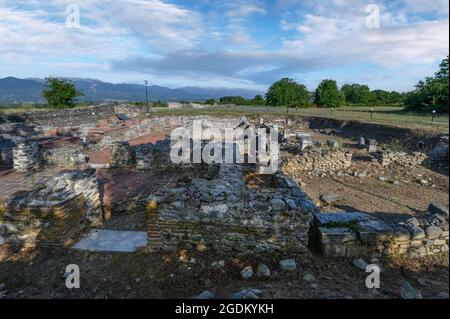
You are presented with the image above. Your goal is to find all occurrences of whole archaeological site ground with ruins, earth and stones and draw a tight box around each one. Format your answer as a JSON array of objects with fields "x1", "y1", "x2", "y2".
[{"x1": 0, "y1": 104, "x2": 449, "y2": 299}]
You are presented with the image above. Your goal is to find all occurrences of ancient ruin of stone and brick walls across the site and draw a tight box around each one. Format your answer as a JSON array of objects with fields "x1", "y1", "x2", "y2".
[{"x1": 0, "y1": 105, "x2": 449, "y2": 258}]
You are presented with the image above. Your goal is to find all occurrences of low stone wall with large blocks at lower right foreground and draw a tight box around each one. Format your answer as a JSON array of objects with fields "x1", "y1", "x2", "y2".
[{"x1": 310, "y1": 204, "x2": 449, "y2": 258}]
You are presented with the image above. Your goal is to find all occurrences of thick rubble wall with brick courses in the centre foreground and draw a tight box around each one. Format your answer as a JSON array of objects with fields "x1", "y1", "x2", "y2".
[{"x1": 147, "y1": 165, "x2": 317, "y2": 254}]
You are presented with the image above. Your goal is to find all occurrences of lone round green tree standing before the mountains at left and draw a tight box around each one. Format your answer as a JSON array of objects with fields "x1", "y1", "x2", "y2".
[{"x1": 42, "y1": 78, "x2": 83, "y2": 109}]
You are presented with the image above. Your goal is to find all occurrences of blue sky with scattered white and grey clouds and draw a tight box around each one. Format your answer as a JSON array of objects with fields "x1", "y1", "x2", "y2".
[{"x1": 0, "y1": 0, "x2": 449, "y2": 90}]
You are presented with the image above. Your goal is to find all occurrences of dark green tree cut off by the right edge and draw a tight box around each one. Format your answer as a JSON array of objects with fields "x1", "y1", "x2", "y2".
[{"x1": 405, "y1": 56, "x2": 449, "y2": 113}]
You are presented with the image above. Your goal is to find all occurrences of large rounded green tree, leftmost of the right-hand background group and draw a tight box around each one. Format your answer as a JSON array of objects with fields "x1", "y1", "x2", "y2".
[{"x1": 266, "y1": 78, "x2": 310, "y2": 107}]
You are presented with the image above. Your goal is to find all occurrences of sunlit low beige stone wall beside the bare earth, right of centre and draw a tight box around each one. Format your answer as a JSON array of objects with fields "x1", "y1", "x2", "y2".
[{"x1": 281, "y1": 147, "x2": 353, "y2": 177}]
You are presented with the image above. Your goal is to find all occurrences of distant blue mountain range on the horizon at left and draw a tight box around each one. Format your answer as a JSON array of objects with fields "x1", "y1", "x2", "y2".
[{"x1": 0, "y1": 77, "x2": 262, "y2": 104}]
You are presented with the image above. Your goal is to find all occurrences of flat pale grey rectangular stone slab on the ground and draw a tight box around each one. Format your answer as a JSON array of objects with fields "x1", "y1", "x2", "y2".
[{"x1": 72, "y1": 229, "x2": 147, "y2": 253}]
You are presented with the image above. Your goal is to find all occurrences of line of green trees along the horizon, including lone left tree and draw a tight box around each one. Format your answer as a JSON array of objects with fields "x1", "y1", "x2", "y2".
[{"x1": 42, "y1": 56, "x2": 449, "y2": 113}]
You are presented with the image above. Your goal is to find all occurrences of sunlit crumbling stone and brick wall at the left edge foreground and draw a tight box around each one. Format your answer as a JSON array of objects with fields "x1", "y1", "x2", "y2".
[{"x1": 0, "y1": 170, "x2": 103, "y2": 245}]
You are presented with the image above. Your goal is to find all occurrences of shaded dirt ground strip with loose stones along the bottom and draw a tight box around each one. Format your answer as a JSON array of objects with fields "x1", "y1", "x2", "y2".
[{"x1": 0, "y1": 248, "x2": 449, "y2": 299}]
